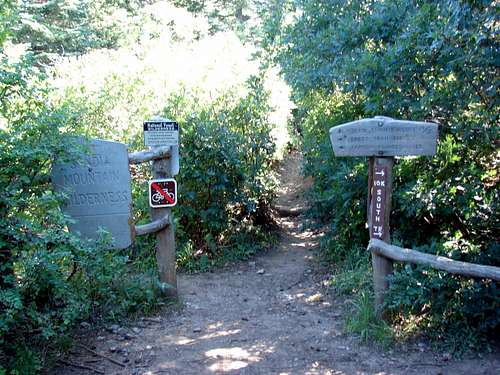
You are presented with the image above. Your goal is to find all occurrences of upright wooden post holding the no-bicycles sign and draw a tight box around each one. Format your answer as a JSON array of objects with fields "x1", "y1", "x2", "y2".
[{"x1": 151, "y1": 148, "x2": 177, "y2": 297}]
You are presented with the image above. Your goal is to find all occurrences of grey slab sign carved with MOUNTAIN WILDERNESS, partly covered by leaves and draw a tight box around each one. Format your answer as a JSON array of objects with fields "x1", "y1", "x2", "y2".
[{"x1": 52, "y1": 139, "x2": 133, "y2": 249}]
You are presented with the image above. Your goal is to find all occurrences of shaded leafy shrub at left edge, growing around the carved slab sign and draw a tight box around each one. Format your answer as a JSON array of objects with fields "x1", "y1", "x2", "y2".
[{"x1": 0, "y1": 45, "x2": 161, "y2": 374}]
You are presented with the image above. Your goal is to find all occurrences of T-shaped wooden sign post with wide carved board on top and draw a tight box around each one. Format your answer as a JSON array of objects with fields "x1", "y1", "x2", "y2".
[{"x1": 330, "y1": 116, "x2": 438, "y2": 315}]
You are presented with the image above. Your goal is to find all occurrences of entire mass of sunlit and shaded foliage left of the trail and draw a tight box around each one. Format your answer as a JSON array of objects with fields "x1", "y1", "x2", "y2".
[{"x1": 0, "y1": 0, "x2": 282, "y2": 374}]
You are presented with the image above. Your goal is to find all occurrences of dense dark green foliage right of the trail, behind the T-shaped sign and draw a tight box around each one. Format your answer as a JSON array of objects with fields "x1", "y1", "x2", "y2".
[{"x1": 263, "y1": 0, "x2": 500, "y2": 350}]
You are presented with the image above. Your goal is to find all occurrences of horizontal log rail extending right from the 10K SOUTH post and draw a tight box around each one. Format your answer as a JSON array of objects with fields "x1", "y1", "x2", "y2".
[{"x1": 368, "y1": 239, "x2": 500, "y2": 281}]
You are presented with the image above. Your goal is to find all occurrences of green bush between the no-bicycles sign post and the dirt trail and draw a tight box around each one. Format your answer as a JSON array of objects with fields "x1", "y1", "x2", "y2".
[{"x1": 165, "y1": 77, "x2": 275, "y2": 268}]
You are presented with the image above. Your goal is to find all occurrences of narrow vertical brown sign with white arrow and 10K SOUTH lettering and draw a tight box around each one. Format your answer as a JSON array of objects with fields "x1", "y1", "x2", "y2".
[{"x1": 370, "y1": 165, "x2": 387, "y2": 239}]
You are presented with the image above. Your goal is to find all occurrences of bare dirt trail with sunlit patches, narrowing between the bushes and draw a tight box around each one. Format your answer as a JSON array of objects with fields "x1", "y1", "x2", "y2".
[{"x1": 51, "y1": 154, "x2": 500, "y2": 375}]
